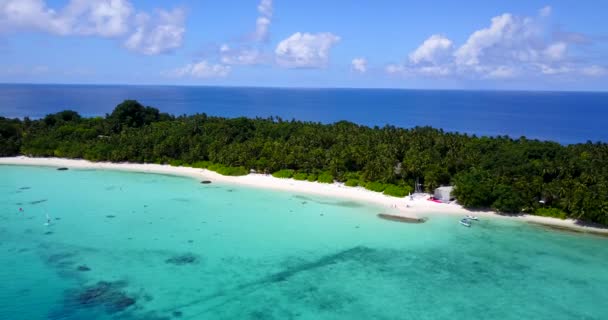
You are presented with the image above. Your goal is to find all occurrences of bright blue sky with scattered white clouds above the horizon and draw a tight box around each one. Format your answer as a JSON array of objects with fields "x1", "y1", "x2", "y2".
[{"x1": 0, "y1": 0, "x2": 608, "y2": 91}]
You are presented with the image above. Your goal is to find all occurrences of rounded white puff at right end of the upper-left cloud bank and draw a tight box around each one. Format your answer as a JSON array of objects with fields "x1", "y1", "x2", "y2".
[{"x1": 125, "y1": 8, "x2": 186, "y2": 55}]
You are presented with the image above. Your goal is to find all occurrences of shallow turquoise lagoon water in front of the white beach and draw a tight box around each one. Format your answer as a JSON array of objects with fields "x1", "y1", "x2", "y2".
[{"x1": 0, "y1": 166, "x2": 608, "y2": 320}]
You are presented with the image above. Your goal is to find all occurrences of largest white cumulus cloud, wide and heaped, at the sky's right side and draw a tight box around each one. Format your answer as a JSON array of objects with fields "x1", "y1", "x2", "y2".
[{"x1": 385, "y1": 7, "x2": 606, "y2": 79}]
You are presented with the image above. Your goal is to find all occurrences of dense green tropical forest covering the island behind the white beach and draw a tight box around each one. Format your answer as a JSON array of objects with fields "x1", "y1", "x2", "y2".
[{"x1": 0, "y1": 101, "x2": 608, "y2": 224}]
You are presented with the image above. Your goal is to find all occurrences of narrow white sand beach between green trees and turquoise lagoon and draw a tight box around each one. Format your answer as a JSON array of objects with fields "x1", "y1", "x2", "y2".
[{"x1": 0, "y1": 156, "x2": 608, "y2": 236}]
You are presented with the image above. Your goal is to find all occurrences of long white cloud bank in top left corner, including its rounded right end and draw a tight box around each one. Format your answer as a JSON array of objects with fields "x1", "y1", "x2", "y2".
[{"x1": 0, "y1": 0, "x2": 185, "y2": 55}]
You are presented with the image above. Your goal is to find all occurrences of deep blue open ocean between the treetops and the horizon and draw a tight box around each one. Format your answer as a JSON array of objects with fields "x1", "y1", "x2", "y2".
[{"x1": 0, "y1": 84, "x2": 608, "y2": 144}]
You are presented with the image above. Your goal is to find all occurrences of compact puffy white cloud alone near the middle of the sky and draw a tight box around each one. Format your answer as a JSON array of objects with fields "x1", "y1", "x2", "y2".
[{"x1": 275, "y1": 32, "x2": 340, "y2": 68}]
